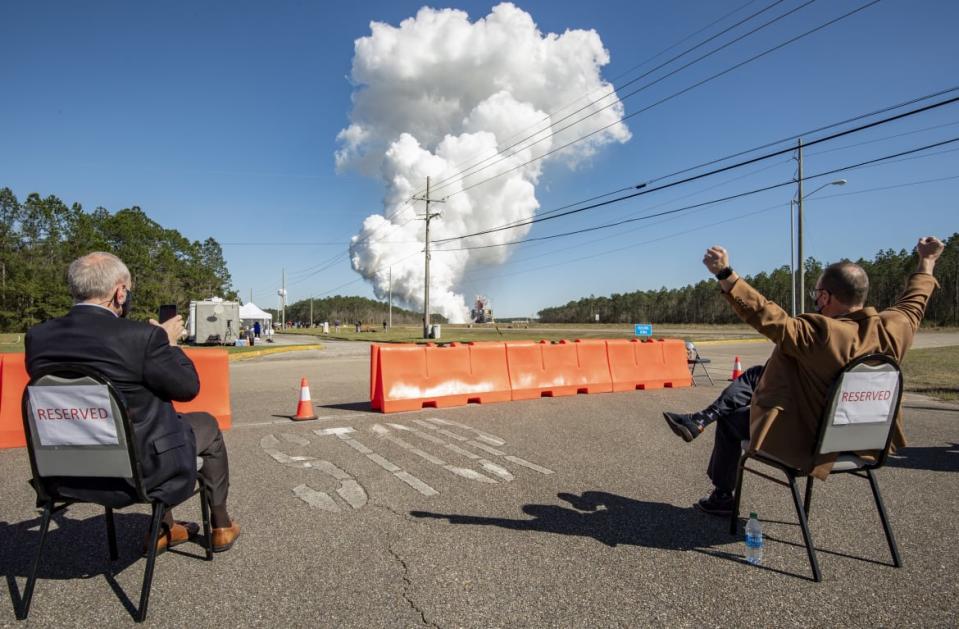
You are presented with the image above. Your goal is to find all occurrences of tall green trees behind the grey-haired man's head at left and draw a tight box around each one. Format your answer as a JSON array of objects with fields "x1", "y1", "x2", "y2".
[{"x1": 0, "y1": 188, "x2": 237, "y2": 332}]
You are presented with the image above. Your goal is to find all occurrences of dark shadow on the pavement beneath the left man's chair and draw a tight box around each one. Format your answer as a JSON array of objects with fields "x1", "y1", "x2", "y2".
[{"x1": 0, "y1": 509, "x2": 179, "y2": 617}]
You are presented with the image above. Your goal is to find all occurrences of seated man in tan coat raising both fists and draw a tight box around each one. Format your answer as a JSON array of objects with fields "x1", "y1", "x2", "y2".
[{"x1": 663, "y1": 237, "x2": 943, "y2": 515}]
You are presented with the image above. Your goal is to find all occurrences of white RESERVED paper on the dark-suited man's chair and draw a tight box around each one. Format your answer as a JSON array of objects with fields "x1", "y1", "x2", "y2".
[{"x1": 29, "y1": 384, "x2": 120, "y2": 446}]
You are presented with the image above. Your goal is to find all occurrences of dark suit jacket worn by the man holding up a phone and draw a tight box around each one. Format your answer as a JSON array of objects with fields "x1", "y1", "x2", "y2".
[{"x1": 26, "y1": 305, "x2": 200, "y2": 506}]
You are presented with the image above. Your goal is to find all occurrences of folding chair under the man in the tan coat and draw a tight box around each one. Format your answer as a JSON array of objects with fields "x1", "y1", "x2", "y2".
[{"x1": 729, "y1": 354, "x2": 902, "y2": 581}]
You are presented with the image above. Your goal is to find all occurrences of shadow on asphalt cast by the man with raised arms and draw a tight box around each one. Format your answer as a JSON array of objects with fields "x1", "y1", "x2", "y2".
[{"x1": 410, "y1": 491, "x2": 737, "y2": 558}]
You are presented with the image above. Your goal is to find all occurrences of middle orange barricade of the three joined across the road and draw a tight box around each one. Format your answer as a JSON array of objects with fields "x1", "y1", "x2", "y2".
[{"x1": 506, "y1": 340, "x2": 613, "y2": 400}]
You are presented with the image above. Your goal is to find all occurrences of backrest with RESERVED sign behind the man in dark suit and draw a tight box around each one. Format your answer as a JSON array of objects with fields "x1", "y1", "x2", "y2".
[{"x1": 22, "y1": 364, "x2": 144, "y2": 498}]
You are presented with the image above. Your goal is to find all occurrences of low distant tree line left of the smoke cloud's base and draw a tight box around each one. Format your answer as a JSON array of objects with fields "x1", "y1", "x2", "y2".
[{"x1": 267, "y1": 295, "x2": 438, "y2": 326}]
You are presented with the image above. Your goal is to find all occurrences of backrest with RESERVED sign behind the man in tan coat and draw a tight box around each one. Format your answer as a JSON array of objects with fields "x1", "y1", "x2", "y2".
[{"x1": 817, "y1": 354, "x2": 902, "y2": 465}]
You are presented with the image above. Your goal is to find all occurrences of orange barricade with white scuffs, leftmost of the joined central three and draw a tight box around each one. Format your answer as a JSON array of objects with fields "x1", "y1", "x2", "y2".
[{"x1": 370, "y1": 343, "x2": 510, "y2": 413}]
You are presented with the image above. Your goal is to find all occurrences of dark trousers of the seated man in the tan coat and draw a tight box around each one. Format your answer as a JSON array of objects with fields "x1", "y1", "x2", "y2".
[{"x1": 706, "y1": 365, "x2": 763, "y2": 492}]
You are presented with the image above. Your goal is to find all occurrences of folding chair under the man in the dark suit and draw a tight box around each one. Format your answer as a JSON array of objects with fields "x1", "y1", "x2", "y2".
[{"x1": 17, "y1": 364, "x2": 213, "y2": 622}]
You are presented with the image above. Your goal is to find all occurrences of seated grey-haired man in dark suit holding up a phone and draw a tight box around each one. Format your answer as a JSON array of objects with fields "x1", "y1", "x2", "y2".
[{"x1": 26, "y1": 252, "x2": 240, "y2": 552}]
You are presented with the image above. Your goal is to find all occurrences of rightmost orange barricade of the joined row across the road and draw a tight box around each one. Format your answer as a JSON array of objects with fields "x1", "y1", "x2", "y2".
[{"x1": 606, "y1": 339, "x2": 692, "y2": 391}]
